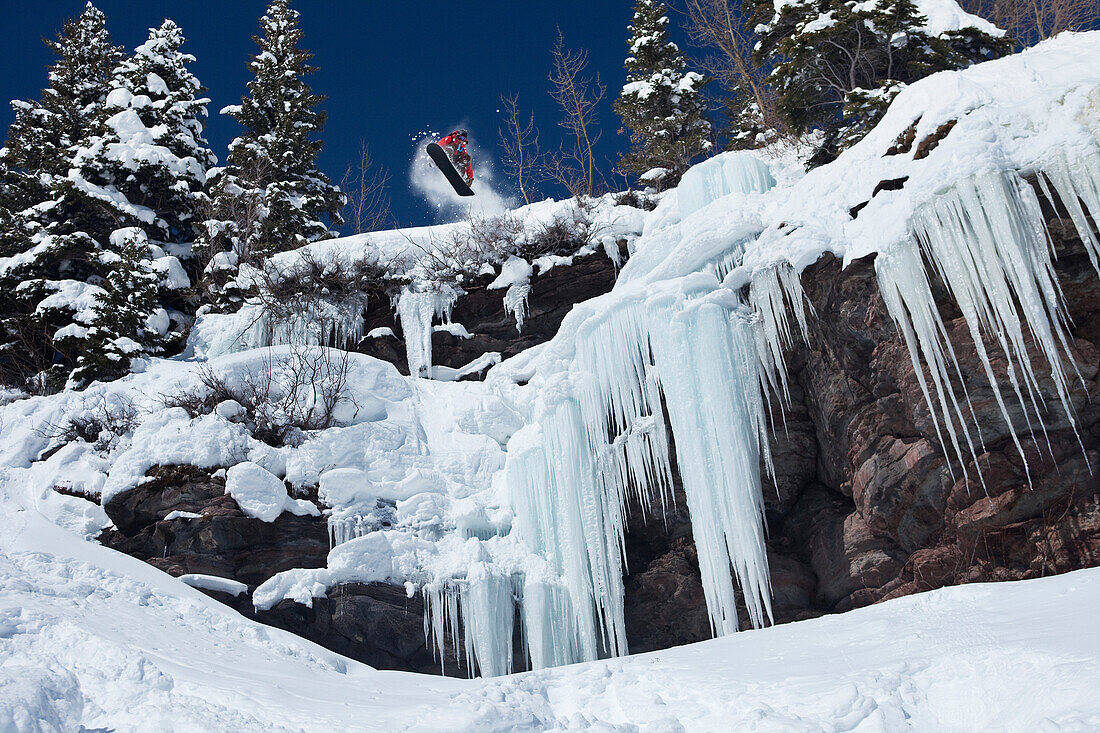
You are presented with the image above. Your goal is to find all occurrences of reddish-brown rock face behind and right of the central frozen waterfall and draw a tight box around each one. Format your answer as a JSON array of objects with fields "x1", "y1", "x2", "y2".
[{"x1": 626, "y1": 192, "x2": 1100, "y2": 650}]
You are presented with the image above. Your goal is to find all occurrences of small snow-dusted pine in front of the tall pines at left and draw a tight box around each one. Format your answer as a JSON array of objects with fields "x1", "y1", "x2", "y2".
[{"x1": 63, "y1": 227, "x2": 169, "y2": 385}]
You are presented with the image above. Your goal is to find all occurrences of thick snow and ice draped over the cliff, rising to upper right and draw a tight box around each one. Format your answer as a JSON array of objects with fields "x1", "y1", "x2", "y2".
[{"x1": 0, "y1": 33, "x2": 1100, "y2": 675}]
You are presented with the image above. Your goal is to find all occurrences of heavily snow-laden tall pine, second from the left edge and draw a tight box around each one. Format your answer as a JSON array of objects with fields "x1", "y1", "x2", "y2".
[{"x1": 0, "y1": 21, "x2": 216, "y2": 386}]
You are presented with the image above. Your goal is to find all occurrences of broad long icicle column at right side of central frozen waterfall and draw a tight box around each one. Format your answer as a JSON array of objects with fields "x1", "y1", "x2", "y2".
[{"x1": 650, "y1": 290, "x2": 771, "y2": 634}]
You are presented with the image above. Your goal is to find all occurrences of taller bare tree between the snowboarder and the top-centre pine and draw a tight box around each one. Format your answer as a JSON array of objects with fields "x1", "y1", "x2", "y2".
[{"x1": 548, "y1": 29, "x2": 607, "y2": 196}]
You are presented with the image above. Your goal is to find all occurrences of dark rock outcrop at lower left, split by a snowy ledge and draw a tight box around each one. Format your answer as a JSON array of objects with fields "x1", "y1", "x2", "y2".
[{"x1": 99, "y1": 466, "x2": 451, "y2": 675}]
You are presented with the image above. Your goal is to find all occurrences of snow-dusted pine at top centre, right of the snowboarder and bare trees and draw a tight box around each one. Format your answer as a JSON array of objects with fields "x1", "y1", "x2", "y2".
[{"x1": 614, "y1": 0, "x2": 711, "y2": 187}]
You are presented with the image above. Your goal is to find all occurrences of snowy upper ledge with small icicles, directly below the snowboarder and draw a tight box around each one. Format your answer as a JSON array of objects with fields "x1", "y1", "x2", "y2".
[{"x1": 187, "y1": 195, "x2": 646, "y2": 365}]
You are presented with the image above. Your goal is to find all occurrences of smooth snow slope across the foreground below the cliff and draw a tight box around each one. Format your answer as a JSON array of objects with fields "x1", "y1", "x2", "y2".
[{"x1": 0, "y1": 511, "x2": 1100, "y2": 733}]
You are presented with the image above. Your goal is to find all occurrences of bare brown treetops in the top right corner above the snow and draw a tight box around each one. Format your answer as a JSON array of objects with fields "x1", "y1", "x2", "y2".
[{"x1": 960, "y1": 0, "x2": 1100, "y2": 46}]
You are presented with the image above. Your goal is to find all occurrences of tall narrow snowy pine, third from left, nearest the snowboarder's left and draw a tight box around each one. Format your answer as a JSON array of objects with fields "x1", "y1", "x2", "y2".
[{"x1": 201, "y1": 0, "x2": 344, "y2": 308}]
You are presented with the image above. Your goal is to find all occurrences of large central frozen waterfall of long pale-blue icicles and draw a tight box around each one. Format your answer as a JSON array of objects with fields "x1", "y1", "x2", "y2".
[{"x1": 506, "y1": 281, "x2": 778, "y2": 669}]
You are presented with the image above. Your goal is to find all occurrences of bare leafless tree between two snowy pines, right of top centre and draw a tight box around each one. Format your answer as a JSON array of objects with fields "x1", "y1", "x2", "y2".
[{"x1": 684, "y1": 0, "x2": 785, "y2": 138}]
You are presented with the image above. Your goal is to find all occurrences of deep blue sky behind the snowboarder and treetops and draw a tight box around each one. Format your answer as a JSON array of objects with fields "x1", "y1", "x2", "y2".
[{"x1": 0, "y1": 0, "x2": 699, "y2": 225}]
